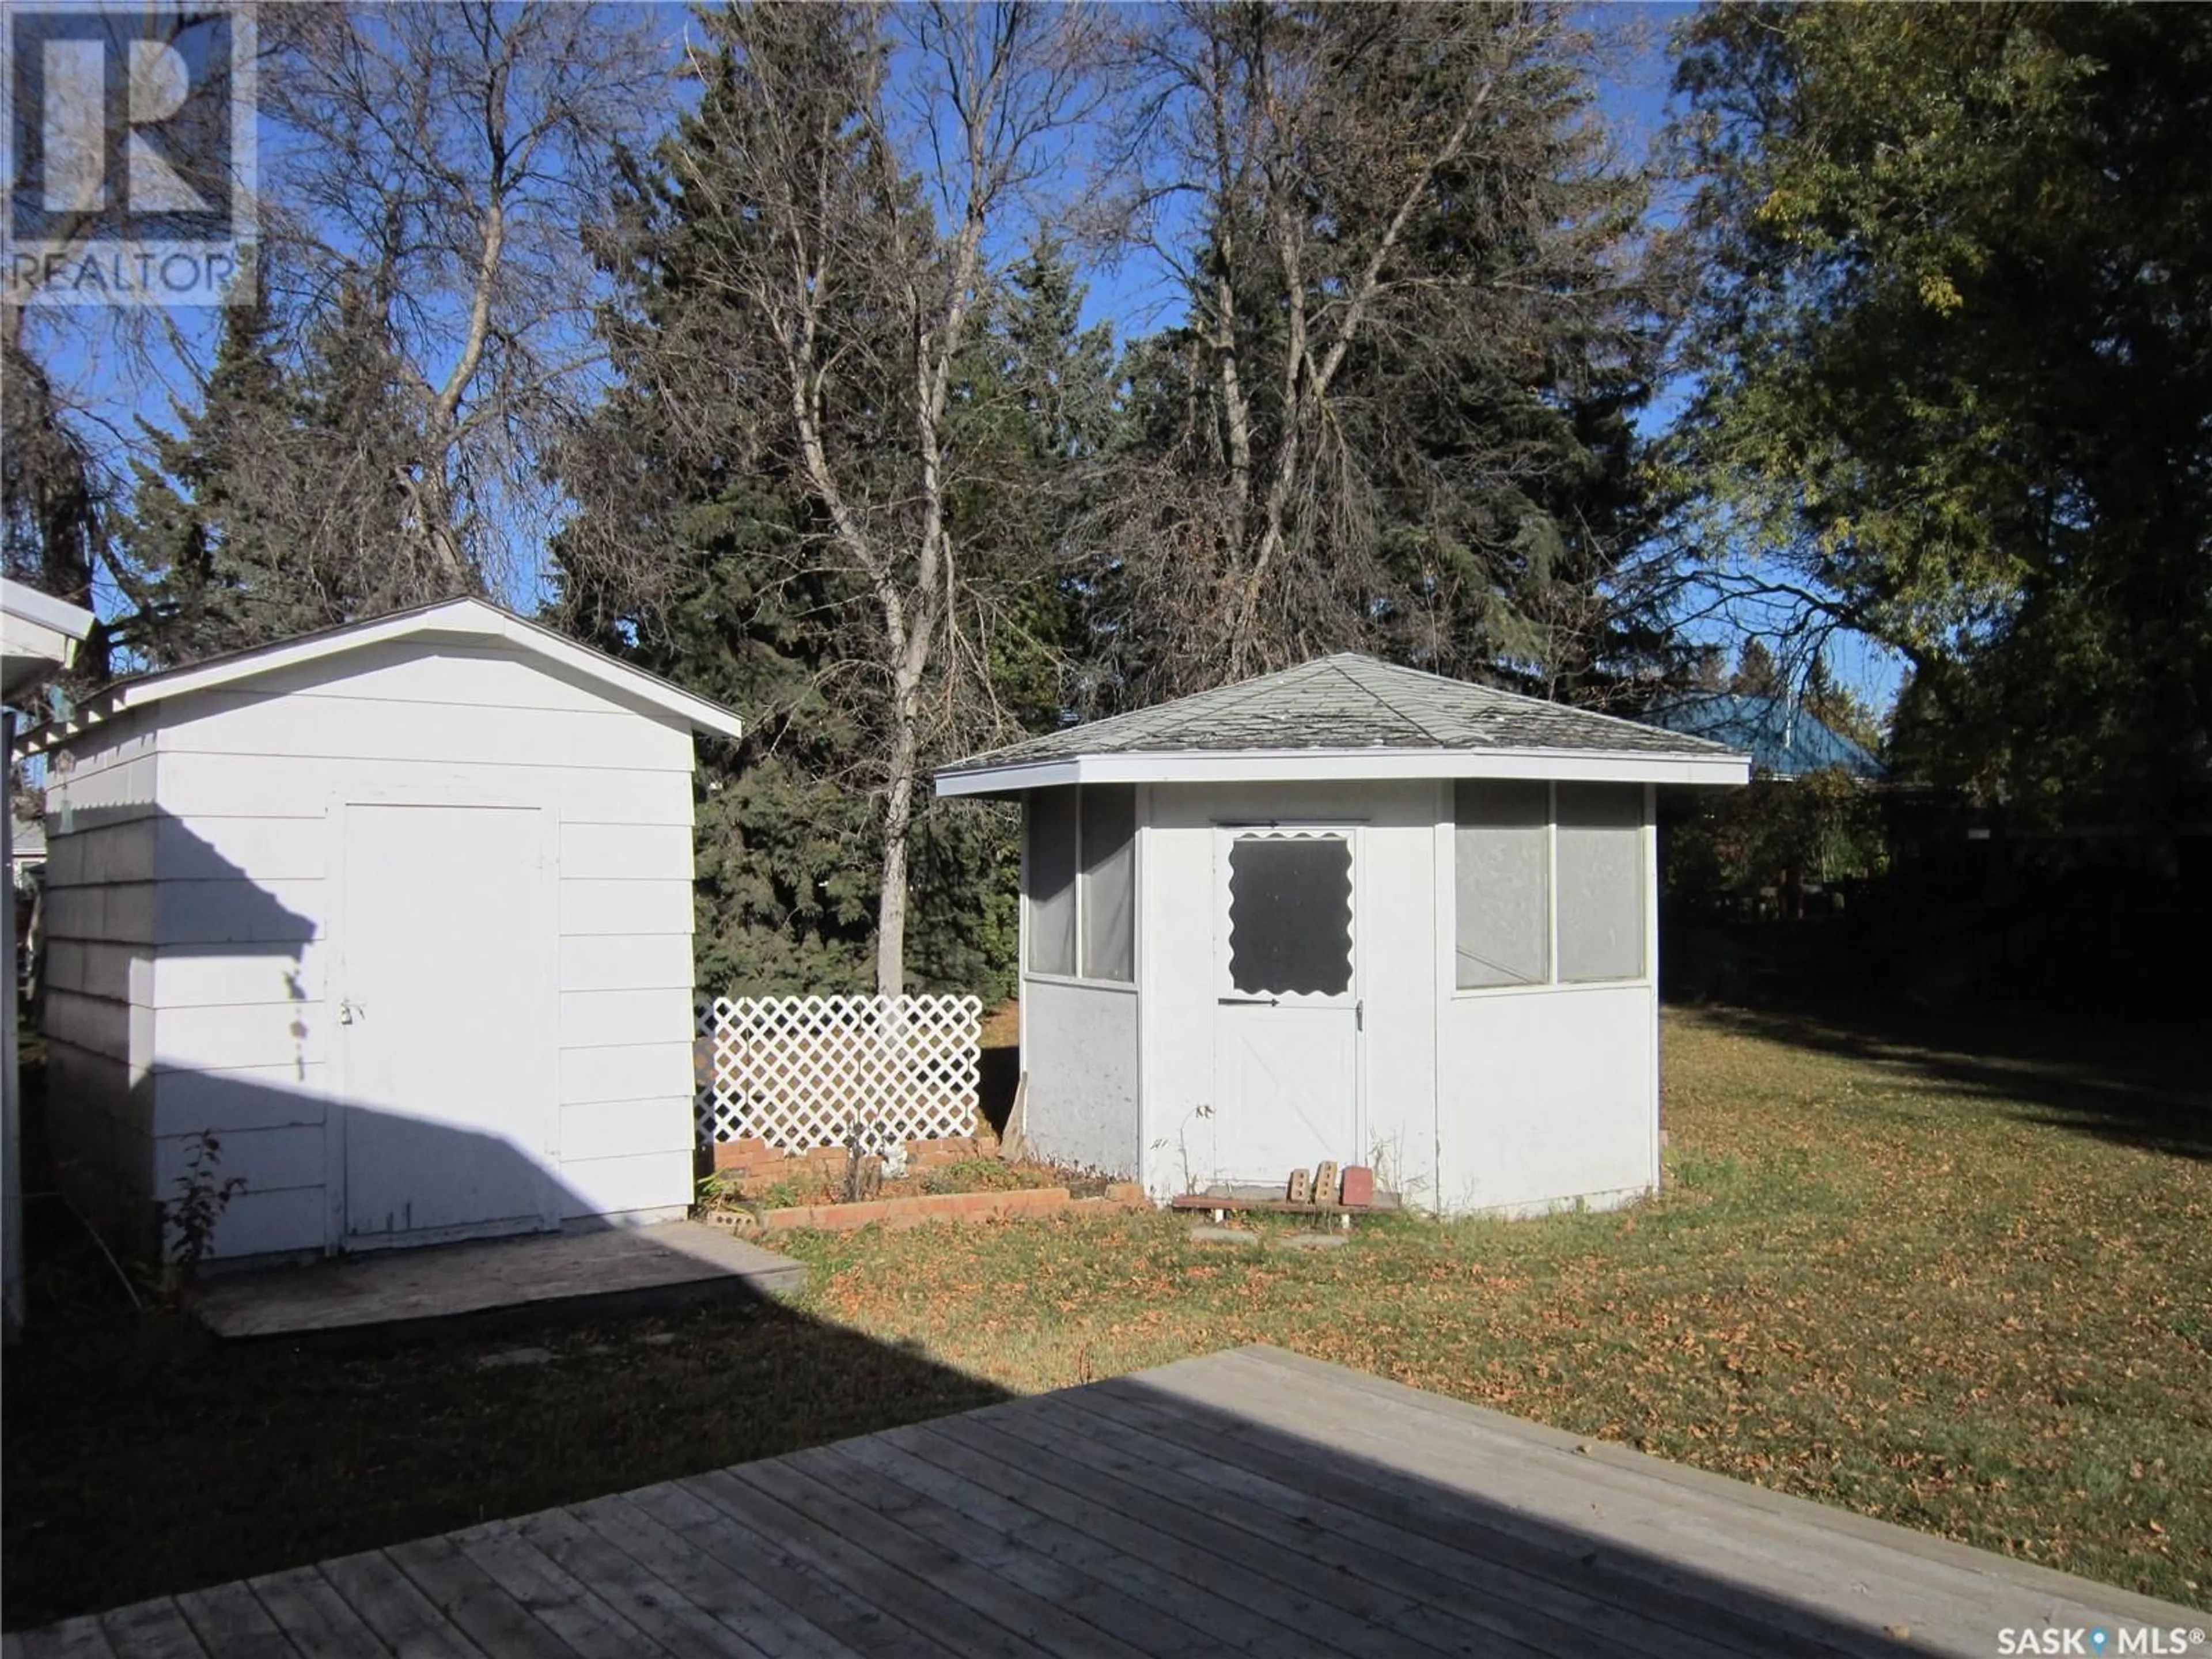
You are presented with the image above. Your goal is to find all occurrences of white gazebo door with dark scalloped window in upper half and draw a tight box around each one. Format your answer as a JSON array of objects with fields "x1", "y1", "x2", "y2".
[{"x1": 1214, "y1": 830, "x2": 1361, "y2": 1181}]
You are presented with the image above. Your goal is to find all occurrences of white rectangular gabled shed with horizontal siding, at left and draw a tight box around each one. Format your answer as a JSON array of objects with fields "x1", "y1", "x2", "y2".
[{"x1": 26, "y1": 600, "x2": 739, "y2": 1256}]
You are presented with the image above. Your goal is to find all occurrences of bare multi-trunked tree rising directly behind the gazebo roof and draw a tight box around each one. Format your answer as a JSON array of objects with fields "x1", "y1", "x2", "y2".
[{"x1": 1099, "y1": 2, "x2": 1663, "y2": 695}]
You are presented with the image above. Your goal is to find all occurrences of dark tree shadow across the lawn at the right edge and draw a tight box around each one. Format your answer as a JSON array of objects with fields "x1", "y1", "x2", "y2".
[{"x1": 1696, "y1": 1004, "x2": 2212, "y2": 1159}]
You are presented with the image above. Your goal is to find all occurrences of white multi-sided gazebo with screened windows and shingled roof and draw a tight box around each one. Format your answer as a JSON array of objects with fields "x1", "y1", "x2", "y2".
[{"x1": 935, "y1": 655, "x2": 1748, "y2": 1214}]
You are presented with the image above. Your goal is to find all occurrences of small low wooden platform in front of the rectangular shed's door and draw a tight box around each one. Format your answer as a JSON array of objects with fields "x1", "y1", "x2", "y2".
[{"x1": 192, "y1": 1221, "x2": 808, "y2": 1336}]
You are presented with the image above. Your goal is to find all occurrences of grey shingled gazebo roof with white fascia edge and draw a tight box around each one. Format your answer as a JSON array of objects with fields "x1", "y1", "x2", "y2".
[{"x1": 938, "y1": 653, "x2": 1745, "y2": 794}]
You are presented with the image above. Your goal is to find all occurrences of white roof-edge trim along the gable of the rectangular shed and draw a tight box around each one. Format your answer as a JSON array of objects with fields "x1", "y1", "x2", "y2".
[{"x1": 20, "y1": 600, "x2": 743, "y2": 754}]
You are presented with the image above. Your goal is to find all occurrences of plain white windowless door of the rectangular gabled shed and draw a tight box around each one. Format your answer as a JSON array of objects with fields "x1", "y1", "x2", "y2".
[{"x1": 334, "y1": 803, "x2": 560, "y2": 1250}]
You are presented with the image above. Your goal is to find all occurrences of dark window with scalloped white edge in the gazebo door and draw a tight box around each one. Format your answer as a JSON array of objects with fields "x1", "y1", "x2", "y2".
[{"x1": 1230, "y1": 836, "x2": 1351, "y2": 995}]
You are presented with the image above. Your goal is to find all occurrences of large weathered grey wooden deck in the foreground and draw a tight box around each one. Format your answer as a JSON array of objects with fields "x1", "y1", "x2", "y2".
[{"x1": 7, "y1": 1347, "x2": 2212, "y2": 1659}]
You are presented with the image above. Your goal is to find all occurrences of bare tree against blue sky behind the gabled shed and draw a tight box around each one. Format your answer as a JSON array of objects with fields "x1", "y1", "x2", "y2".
[{"x1": 263, "y1": 0, "x2": 675, "y2": 604}]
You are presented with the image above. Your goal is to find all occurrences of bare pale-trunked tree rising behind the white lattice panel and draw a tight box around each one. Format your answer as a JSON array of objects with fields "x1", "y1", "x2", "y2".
[{"x1": 571, "y1": 2, "x2": 1097, "y2": 995}]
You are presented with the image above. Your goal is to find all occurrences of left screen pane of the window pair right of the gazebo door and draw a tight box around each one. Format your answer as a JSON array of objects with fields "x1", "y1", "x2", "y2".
[{"x1": 1451, "y1": 779, "x2": 1551, "y2": 991}]
